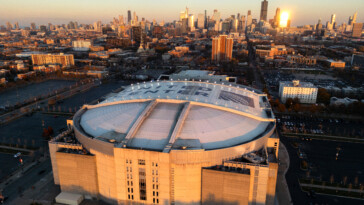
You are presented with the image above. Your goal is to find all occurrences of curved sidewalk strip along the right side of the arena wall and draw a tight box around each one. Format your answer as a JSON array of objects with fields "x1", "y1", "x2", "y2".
[{"x1": 276, "y1": 142, "x2": 293, "y2": 205}]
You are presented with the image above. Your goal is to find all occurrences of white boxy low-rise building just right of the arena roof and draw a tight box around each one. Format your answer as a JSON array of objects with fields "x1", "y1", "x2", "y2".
[{"x1": 279, "y1": 80, "x2": 318, "y2": 104}]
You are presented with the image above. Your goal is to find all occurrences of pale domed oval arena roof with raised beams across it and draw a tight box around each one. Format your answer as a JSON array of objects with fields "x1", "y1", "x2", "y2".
[{"x1": 80, "y1": 81, "x2": 274, "y2": 152}]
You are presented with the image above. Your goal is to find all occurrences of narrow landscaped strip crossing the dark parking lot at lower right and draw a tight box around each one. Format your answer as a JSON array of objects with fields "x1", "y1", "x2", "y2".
[{"x1": 299, "y1": 179, "x2": 364, "y2": 200}]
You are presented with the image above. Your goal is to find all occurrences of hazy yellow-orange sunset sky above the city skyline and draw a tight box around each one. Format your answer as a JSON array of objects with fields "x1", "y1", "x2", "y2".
[{"x1": 0, "y1": 0, "x2": 364, "y2": 26}]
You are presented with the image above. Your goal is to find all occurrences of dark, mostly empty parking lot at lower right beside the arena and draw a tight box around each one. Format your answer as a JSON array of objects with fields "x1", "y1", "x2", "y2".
[{"x1": 281, "y1": 135, "x2": 364, "y2": 204}]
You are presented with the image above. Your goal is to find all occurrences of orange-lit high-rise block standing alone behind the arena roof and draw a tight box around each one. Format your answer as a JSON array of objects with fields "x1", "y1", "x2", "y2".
[{"x1": 211, "y1": 35, "x2": 234, "y2": 61}]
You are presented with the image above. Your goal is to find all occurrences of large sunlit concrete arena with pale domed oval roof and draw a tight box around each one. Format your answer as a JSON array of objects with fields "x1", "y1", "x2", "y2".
[{"x1": 49, "y1": 81, "x2": 279, "y2": 204}]
